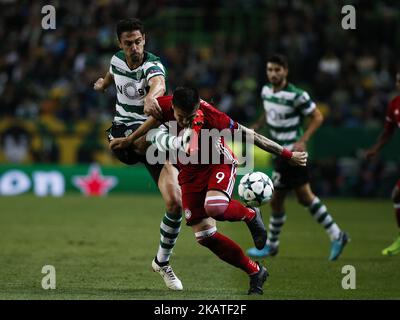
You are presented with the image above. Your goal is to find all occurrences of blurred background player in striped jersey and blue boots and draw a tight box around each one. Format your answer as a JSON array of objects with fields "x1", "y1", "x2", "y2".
[{"x1": 247, "y1": 55, "x2": 348, "y2": 260}]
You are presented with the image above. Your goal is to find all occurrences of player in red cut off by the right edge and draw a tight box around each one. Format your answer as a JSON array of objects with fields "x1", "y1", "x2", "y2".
[{"x1": 365, "y1": 72, "x2": 400, "y2": 256}]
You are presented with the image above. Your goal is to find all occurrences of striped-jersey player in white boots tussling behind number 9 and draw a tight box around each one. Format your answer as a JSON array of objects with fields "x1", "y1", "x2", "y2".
[{"x1": 94, "y1": 19, "x2": 183, "y2": 290}]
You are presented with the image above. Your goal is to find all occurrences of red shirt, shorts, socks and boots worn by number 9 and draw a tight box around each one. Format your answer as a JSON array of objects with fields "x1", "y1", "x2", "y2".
[{"x1": 157, "y1": 96, "x2": 268, "y2": 282}]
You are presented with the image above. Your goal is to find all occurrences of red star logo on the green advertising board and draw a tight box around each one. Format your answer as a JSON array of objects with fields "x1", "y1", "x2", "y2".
[{"x1": 72, "y1": 165, "x2": 118, "y2": 196}]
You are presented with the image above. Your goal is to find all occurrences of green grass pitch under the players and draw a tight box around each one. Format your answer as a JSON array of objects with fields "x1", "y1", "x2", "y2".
[{"x1": 0, "y1": 195, "x2": 400, "y2": 300}]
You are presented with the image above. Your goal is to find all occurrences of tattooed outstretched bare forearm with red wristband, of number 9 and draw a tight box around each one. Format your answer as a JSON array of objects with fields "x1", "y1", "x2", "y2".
[{"x1": 239, "y1": 124, "x2": 307, "y2": 166}]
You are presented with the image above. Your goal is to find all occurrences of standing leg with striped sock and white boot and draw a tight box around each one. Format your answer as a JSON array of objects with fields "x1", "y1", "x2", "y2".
[{"x1": 152, "y1": 162, "x2": 183, "y2": 290}]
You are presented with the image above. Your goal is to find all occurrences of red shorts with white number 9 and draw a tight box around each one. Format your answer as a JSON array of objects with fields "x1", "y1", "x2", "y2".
[{"x1": 179, "y1": 164, "x2": 236, "y2": 226}]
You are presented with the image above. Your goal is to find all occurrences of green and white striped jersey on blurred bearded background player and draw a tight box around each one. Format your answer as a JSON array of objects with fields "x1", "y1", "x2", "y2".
[{"x1": 261, "y1": 83, "x2": 316, "y2": 150}]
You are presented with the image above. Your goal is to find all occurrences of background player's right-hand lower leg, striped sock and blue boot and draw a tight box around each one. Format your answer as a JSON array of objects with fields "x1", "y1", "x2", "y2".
[{"x1": 295, "y1": 183, "x2": 349, "y2": 261}]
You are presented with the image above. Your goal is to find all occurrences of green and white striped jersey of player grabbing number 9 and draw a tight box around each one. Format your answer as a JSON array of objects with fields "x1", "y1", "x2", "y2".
[{"x1": 109, "y1": 50, "x2": 166, "y2": 125}]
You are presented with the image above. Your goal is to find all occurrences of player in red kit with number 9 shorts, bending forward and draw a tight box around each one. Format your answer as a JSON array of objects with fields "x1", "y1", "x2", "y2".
[{"x1": 110, "y1": 87, "x2": 307, "y2": 294}]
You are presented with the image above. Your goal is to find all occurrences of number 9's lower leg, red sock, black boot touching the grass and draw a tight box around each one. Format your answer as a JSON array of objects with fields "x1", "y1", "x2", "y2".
[{"x1": 192, "y1": 218, "x2": 268, "y2": 294}]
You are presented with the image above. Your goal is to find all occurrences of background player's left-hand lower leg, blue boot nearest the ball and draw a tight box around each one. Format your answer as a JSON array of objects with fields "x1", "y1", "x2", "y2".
[{"x1": 247, "y1": 189, "x2": 288, "y2": 258}]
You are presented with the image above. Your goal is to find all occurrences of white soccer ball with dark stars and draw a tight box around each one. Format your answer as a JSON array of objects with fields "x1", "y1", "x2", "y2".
[{"x1": 238, "y1": 172, "x2": 274, "y2": 207}]
